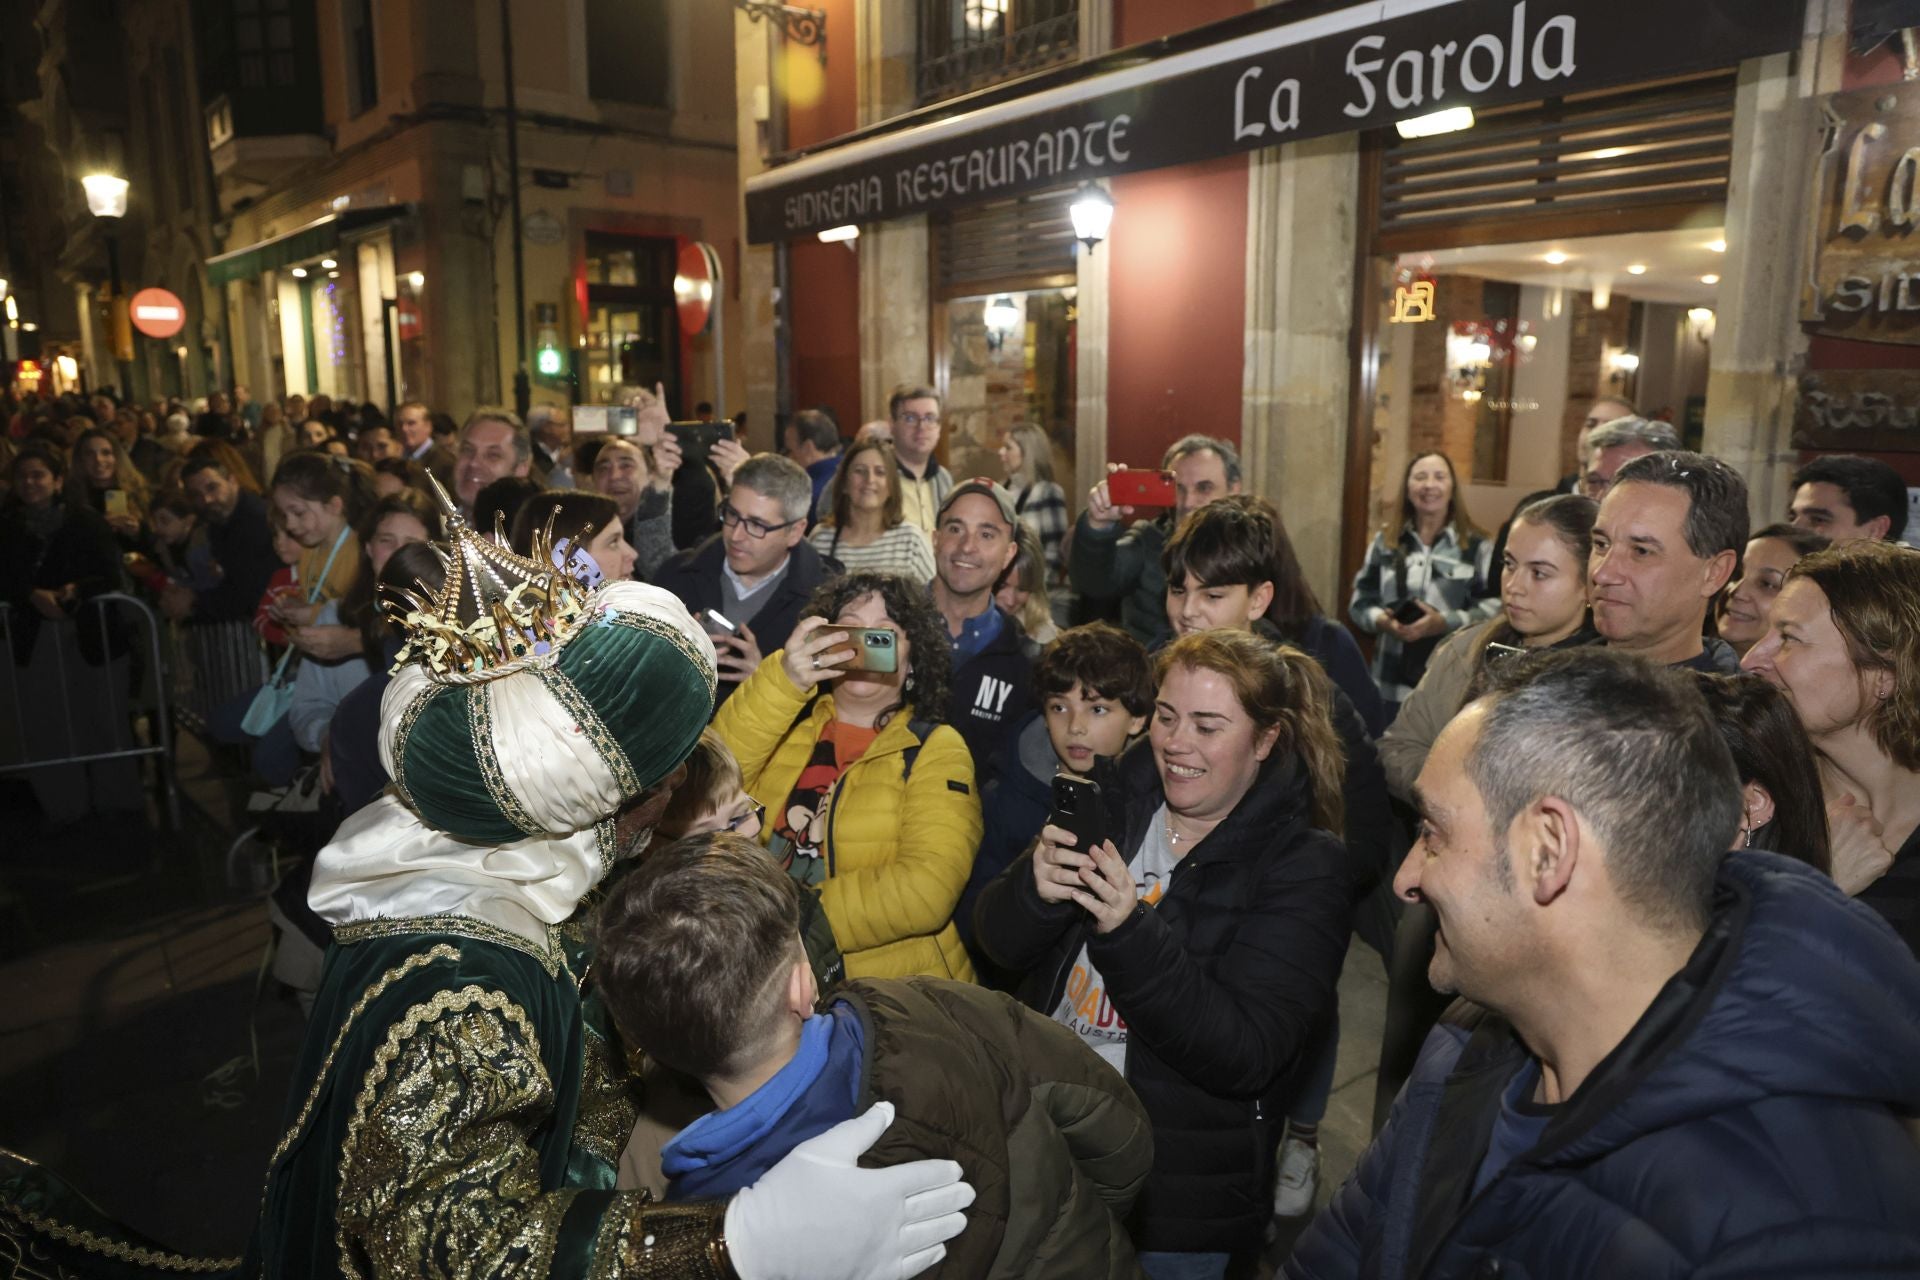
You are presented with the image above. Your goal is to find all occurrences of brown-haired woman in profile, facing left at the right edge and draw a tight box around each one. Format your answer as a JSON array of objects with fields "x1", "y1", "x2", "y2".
[{"x1": 1740, "y1": 541, "x2": 1920, "y2": 954}]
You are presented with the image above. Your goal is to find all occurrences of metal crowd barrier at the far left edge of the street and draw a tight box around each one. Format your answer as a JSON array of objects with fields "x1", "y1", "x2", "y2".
[{"x1": 0, "y1": 591, "x2": 180, "y2": 831}]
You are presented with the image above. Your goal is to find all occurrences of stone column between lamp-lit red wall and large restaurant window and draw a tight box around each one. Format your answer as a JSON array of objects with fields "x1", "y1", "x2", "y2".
[{"x1": 1240, "y1": 134, "x2": 1359, "y2": 616}]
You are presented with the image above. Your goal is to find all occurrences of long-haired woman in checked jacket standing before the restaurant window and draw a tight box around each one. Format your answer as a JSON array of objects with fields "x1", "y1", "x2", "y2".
[{"x1": 1346, "y1": 453, "x2": 1500, "y2": 720}]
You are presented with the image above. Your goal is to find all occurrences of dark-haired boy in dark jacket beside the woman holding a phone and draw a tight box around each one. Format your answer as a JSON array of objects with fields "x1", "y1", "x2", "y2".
[{"x1": 954, "y1": 622, "x2": 1154, "y2": 990}]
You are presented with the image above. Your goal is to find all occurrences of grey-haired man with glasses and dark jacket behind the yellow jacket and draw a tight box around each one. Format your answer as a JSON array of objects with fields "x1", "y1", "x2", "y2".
[{"x1": 655, "y1": 453, "x2": 826, "y2": 700}]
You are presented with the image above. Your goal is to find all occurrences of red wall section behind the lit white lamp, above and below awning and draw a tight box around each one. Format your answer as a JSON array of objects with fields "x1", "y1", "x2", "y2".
[{"x1": 1098, "y1": 0, "x2": 1252, "y2": 466}]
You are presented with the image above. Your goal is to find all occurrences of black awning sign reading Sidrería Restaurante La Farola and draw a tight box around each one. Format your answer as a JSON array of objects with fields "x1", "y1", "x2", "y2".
[{"x1": 747, "y1": 0, "x2": 1803, "y2": 244}]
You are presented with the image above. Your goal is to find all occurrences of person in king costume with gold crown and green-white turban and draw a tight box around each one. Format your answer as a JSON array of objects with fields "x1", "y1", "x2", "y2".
[{"x1": 0, "y1": 493, "x2": 972, "y2": 1280}]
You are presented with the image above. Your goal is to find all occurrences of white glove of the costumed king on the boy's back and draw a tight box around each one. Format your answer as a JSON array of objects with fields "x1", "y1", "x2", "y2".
[{"x1": 726, "y1": 1102, "x2": 973, "y2": 1280}]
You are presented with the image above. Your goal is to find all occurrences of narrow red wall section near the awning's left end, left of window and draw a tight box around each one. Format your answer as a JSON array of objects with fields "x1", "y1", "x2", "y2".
[{"x1": 785, "y1": 0, "x2": 860, "y2": 434}]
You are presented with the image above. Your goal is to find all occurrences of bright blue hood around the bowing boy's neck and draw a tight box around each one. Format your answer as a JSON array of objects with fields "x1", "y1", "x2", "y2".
[{"x1": 660, "y1": 1002, "x2": 866, "y2": 1199}]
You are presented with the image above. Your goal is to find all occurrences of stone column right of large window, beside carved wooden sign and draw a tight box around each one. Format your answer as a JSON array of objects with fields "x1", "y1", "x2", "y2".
[{"x1": 1701, "y1": 0, "x2": 1847, "y2": 528}]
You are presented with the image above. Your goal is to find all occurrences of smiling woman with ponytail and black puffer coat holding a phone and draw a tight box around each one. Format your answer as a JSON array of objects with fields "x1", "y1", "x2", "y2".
[{"x1": 975, "y1": 629, "x2": 1354, "y2": 1278}]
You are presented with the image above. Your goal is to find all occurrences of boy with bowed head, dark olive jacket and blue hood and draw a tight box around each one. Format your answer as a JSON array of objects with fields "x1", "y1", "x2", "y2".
[{"x1": 597, "y1": 833, "x2": 1152, "y2": 1280}]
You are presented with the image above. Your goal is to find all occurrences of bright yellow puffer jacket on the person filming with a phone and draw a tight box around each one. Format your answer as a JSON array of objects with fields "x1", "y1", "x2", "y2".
[{"x1": 714, "y1": 652, "x2": 981, "y2": 983}]
